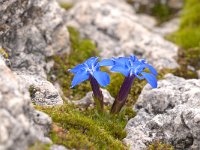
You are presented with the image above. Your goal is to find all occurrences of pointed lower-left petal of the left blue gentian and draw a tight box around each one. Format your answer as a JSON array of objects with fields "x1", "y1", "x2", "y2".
[{"x1": 71, "y1": 70, "x2": 89, "y2": 88}]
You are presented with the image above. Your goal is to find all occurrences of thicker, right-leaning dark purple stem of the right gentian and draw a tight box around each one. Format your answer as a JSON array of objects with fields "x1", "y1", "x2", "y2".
[{"x1": 110, "y1": 75, "x2": 135, "y2": 114}]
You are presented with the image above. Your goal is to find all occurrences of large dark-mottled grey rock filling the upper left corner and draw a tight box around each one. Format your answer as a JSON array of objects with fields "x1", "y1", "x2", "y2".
[{"x1": 0, "y1": 0, "x2": 69, "y2": 77}]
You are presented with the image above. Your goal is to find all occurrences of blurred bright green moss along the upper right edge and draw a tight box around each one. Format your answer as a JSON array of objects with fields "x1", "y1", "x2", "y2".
[{"x1": 167, "y1": 0, "x2": 200, "y2": 72}]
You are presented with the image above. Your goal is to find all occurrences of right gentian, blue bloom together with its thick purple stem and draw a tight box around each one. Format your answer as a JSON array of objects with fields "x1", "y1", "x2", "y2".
[{"x1": 99, "y1": 55, "x2": 157, "y2": 114}]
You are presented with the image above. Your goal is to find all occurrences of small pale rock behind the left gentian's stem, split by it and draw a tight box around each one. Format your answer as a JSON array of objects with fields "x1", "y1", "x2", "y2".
[{"x1": 70, "y1": 89, "x2": 114, "y2": 108}]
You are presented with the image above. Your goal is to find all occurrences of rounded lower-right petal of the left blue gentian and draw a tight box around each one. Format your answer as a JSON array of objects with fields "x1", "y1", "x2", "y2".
[{"x1": 93, "y1": 71, "x2": 110, "y2": 86}]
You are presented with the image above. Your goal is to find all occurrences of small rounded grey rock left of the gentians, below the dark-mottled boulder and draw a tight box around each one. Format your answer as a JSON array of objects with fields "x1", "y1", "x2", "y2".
[{"x1": 18, "y1": 74, "x2": 63, "y2": 106}]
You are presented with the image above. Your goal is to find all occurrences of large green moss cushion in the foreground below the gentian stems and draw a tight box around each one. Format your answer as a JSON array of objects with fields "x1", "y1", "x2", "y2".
[{"x1": 37, "y1": 104, "x2": 135, "y2": 149}]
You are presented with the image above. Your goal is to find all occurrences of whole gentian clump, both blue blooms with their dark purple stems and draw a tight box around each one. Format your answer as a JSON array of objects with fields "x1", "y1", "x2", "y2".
[{"x1": 69, "y1": 55, "x2": 157, "y2": 114}]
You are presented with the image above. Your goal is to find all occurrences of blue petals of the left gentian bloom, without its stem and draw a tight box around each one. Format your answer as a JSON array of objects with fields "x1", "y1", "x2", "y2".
[{"x1": 69, "y1": 57, "x2": 110, "y2": 88}]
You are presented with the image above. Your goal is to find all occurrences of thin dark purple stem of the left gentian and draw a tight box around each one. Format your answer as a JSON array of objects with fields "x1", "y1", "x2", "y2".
[{"x1": 89, "y1": 76, "x2": 103, "y2": 112}]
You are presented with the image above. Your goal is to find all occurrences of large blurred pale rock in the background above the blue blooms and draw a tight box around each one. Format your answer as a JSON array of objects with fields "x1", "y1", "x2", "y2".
[{"x1": 67, "y1": 0, "x2": 178, "y2": 69}]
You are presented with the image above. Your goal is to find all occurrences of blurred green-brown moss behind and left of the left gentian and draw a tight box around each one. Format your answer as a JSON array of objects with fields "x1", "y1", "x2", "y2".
[{"x1": 48, "y1": 27, "x2": 98, "y2": 99}]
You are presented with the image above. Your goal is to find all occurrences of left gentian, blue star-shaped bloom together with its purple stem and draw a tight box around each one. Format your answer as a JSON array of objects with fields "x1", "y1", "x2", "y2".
[{"x1": 69, "y1": 57, "x2": 110, "y2": 111}]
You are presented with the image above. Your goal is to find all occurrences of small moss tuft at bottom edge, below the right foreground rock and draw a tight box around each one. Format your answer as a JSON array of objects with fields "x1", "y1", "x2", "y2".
[{"x1": 147, "y1": 141, "x2": 174, "y2": 150}]
